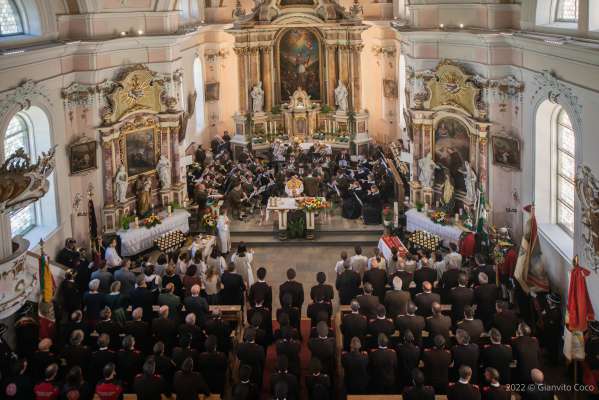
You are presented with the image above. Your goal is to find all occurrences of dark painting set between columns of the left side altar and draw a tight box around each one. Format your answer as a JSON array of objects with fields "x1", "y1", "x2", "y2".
[{"x1": 125, "y1": 127, "x2": 159, "y2": 178}]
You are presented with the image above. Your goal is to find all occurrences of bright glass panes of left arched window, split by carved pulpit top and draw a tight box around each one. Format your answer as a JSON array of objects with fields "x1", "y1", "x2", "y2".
[{"x1": 4, "y1": 114, "x2": 37, "y2": 235}]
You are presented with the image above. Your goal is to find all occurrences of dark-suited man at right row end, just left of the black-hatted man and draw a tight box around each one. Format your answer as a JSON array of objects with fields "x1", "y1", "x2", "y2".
[{"x1": 512, "y1": 322, "x2": 540, "y2": 383}]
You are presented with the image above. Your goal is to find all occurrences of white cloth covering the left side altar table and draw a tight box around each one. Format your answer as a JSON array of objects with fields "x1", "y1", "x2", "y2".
[{"x1": 117, "y1": 209, "x2": 191, "y2": 257}]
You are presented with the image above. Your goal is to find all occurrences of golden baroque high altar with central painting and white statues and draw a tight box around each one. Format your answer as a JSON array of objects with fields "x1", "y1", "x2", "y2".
[{"x1": 228, "y1": 0, "x2": 370, "y2": 154}]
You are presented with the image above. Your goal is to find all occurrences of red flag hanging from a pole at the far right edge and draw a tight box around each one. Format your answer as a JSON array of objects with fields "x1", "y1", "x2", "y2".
[{"x1": 568, "y1": 259, "x2": 595, "y2": 332}]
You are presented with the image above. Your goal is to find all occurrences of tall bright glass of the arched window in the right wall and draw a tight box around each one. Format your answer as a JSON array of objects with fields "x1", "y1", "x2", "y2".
[{"x1": 555, "y1": 109, "x2": 576, "y2": 236}]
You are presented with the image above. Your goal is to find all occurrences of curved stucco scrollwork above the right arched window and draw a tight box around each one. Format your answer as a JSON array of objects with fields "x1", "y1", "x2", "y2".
[{"x1": 532, "y1": 69, "x2": 582, "y2": 132}]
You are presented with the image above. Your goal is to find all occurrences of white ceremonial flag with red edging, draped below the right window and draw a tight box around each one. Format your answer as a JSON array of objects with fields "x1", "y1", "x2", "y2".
[{"x1": 514, "y1": 205, "x2": 549, "y2": 293}]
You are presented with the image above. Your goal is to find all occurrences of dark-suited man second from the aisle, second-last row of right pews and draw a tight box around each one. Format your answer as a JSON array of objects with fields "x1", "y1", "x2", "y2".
[{"x1": 368, "y1": 333, "x2": 397, "y2": 393}]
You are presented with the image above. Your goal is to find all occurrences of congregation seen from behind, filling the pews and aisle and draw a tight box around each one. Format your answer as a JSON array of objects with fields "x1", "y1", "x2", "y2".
[{"x1": 0, "y1": 228, "x2": 561, "y2": 400}]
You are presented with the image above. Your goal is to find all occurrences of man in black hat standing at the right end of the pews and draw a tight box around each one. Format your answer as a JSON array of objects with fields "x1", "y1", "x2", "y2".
[{"x1": 538, "y1": 293, "x2": 563, "y2": 364}]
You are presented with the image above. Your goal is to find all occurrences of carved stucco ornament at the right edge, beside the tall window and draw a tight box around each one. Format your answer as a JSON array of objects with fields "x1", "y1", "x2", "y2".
[{"x1": 576, "y1": 165, "x2": 599, "y2": 273}]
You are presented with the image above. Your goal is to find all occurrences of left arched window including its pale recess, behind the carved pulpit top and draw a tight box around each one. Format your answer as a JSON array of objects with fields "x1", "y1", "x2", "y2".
[{"x1": 0, "y1": 106, "x2": 58, "y2": 239}]
